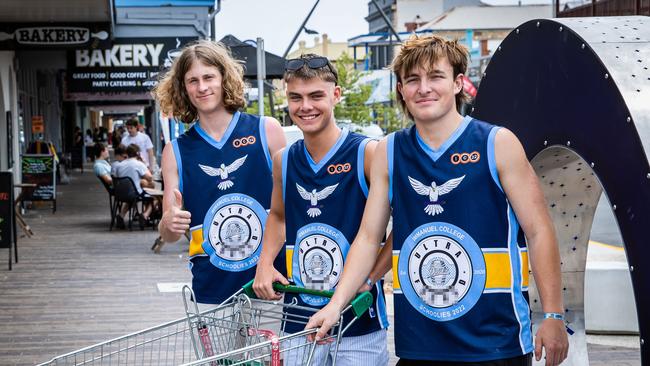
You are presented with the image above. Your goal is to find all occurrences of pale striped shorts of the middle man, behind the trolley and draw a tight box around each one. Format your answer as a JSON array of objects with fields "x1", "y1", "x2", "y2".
[{"x1": 281, "y1": 329, "x2": 388, "y2": 366}]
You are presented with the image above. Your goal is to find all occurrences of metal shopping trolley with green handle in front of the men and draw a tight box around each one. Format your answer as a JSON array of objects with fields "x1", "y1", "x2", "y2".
[{"x1": 39, "y1": 281, "x2": 373, "y2": 366}]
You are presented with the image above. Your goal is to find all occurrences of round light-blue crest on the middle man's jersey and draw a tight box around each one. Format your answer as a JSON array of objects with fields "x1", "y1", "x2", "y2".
[{"x1": 292, "y1": 223, "x2": 350, "y2": 306}]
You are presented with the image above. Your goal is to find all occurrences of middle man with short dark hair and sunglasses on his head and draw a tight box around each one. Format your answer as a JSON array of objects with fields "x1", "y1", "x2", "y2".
[{"x1": 253, "y1": 54, "x2": 391, "y2": 366}]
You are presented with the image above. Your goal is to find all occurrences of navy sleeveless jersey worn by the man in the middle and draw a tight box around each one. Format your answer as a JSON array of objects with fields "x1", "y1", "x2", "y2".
[{"x1": 282, "y1": 129, "x2": 388, "y2": 336}]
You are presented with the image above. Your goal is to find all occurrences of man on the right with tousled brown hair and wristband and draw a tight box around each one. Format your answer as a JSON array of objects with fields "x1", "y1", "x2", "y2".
[{"x1": 307, "y1": 36, "x2": 568, "y2": 366}]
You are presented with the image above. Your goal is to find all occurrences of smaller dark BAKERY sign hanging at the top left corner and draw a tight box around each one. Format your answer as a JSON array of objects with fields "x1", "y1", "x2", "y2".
[{"x1": 0, "y1": 23, "x2": 110, "y2": 49}]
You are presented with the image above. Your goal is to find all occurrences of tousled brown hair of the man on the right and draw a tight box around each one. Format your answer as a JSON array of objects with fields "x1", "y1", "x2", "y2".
[{"x1": 390, "y1": 34, "x2": 469, "y2": 120}]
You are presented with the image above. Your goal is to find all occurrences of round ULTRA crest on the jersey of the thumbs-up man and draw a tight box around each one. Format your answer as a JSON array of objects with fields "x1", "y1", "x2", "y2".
[{"x1": 203, "y1": 193, "x2": 267, "y2": 272}]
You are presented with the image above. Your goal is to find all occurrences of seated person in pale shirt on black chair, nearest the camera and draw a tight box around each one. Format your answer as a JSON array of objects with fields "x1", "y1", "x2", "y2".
[{"x1": 111, "y1": 144, "x2": 154, "y2": 227}]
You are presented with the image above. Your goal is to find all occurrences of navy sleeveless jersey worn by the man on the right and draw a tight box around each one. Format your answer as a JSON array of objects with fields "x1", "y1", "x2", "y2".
[{"x1": 387, "y1": 117, "x2": 533, "y2": 362}]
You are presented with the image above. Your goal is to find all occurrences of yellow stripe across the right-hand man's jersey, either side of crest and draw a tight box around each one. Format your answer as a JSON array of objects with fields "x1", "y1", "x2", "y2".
[{"x1": 393, "y1": 251, "x2": 529, "y2": 290}]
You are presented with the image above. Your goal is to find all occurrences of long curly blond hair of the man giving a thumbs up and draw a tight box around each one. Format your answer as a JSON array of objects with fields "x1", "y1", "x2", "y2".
[{"x1": 151, "y1": 40, "x2": 246, "y2": 123}]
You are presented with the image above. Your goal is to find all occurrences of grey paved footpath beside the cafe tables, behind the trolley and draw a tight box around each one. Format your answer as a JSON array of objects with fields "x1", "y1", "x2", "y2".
[{"x1": 0, "y1": 169, "x2": 640, "y2": 366}]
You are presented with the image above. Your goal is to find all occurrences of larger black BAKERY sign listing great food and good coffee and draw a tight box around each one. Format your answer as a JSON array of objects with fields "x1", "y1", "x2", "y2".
[{"x1": 66, "y1": 37, "x2": 198, "y2": 94}]
